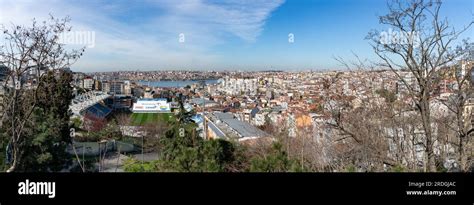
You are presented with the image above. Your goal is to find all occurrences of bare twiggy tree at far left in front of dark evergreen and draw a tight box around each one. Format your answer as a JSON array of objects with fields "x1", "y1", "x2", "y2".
[{"x1": 0, "y1": 16, "x2": 85, "y2": 172}]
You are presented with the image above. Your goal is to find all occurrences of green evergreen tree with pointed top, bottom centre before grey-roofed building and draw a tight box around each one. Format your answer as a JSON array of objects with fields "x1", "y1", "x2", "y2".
[{"x1": 125, "y1": 95, "x2": 248, "y2": 172}]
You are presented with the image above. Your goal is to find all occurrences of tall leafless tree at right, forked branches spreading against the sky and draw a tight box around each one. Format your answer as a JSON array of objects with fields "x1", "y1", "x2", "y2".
[{"x1": 368, "y1": 0, "x2": 473, "y2": 172}]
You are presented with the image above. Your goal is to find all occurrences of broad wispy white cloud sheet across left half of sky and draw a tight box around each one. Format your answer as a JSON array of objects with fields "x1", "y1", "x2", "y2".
[{"x1": 0, "y1": 0, "x2": 284, "y2": 71}]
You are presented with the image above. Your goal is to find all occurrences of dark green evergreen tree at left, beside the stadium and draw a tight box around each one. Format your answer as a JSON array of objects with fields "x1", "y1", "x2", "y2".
[{"x1": 13, "y1": 71, "x2": 73, "y2": 171}]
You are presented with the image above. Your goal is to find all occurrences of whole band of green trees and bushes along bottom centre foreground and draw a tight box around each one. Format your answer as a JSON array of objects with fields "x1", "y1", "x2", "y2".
[{"x1": 124, "y1": 95, "x2": 303, "y2": 172}]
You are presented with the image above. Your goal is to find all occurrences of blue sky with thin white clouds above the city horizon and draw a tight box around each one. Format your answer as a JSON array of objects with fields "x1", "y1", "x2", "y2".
[{"x1": 0, "y1": 0, "x2": 474, "y2": 72}]
